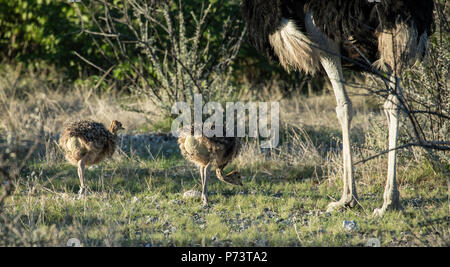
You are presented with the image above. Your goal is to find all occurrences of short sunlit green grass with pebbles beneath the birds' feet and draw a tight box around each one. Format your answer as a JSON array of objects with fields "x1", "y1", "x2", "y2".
[{"x1": 5, "y1": 154, "x2": 449, "y2": 246}]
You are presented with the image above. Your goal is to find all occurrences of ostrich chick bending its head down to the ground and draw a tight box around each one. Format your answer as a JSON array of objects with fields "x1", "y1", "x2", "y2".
[{"x1": 178, "y1": 132, "x2": 242, "y2": 205}]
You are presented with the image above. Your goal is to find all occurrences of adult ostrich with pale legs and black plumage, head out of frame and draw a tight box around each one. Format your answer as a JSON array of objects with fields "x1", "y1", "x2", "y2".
[{"x1": 242, "y1": 0, "x2": 434, "y2": 215}]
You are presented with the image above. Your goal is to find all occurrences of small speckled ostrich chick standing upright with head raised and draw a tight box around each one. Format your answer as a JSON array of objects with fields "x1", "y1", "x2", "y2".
[{"x1": 59, "y1": 120, "x2": 124, "y2": 198}]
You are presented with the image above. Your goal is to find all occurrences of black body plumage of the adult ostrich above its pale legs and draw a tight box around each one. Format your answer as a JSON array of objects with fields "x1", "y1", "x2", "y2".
[{"x1": 242, "y1": 0, "x2": 434, "y2": 70}]
